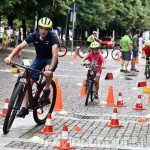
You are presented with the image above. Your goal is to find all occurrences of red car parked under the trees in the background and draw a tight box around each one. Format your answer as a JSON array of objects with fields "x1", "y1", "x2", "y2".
[{"x1": 100, "y1": 36, "x2": 115, "y2": 48}]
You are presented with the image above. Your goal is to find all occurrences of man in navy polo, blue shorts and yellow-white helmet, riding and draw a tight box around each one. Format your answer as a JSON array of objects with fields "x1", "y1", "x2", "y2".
[{"x1": 4, "y1": 17, "x2": 59, "y2": 117}]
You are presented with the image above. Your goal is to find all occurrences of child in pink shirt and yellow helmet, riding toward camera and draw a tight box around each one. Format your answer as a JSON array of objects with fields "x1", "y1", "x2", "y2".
[{"x1": 81, "y1": 42, "x2": 106, "y2": 98}]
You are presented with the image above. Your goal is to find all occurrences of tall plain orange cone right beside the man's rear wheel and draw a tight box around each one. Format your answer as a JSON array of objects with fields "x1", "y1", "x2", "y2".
[{"x1": 54, "y1": 86, "x2": 63, "y2": 110}]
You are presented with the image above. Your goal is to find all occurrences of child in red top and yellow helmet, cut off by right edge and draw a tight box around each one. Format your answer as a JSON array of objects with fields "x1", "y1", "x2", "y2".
[{"x1": 142, "y1": 40, "x2": 150, "y2": 74}]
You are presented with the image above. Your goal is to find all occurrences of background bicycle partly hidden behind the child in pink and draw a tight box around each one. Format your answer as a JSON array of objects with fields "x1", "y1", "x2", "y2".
[{"x1": 77, "y1": 46, "x2": 108, "y2": 59}]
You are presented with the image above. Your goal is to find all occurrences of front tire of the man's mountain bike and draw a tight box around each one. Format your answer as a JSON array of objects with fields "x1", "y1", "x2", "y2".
[{"x1": 3, "y1": 82, "x2": 26, "y2": 134}]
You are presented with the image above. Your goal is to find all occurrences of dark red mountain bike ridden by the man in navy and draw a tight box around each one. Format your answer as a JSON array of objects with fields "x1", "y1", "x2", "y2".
[{"x1": 3, "y1": 62, "x2": 57, "y2": 134}]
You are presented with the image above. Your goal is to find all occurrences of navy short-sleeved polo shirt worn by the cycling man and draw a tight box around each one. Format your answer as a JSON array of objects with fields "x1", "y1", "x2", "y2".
[{"x1": 25, "y1": 31, "x2": 59, "y2": 59}]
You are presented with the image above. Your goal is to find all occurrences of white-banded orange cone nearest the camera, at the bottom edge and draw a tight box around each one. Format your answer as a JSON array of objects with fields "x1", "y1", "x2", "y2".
[{"x1": 53, "y1": 125, "x2": 76, "y2": 150}]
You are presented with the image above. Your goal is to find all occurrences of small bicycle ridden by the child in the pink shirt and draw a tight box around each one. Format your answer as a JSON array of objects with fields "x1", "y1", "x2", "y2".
[{"x1": 84, "y1": 64, "x2": 101, "y2": 106}]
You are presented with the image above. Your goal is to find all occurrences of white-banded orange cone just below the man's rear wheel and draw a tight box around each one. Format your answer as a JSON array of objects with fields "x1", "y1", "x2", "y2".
[{"x1": 39, "y1": 113, "x2": 56, "y2": 134}]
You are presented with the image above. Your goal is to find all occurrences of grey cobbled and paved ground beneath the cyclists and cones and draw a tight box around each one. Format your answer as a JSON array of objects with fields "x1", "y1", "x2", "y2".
[{"x1": 0, "y1": 48, "x2": 150, "y2": 150}]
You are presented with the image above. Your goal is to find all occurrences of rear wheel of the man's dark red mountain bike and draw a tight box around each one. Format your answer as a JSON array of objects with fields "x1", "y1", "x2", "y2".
[{"x1": 33, "y1": 80, "x2": 57, "y2": 125}]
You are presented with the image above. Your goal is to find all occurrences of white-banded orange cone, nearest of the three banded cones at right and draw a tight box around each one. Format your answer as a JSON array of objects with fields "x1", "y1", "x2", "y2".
[{"x1": 106, "y1": 108, "x2": 123, "y2": 128}]
